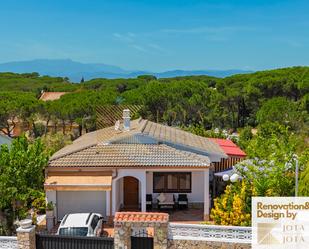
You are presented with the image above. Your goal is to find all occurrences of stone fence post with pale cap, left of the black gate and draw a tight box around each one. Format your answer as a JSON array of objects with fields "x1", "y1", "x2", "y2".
[{"x1": 16, "y1": 220, "x2": 36, "y2": 249}]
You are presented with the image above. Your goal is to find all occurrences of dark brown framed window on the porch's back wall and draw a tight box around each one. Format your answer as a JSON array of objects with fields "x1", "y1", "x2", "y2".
[{"x1": 153, "y1": 172, "x2": 191, "y2": 193}]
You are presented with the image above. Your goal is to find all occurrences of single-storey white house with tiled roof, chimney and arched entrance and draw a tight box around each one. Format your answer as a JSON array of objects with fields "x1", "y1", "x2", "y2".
[{"x1": 44, "y1": 110, "x2": 228, "y2": 220}]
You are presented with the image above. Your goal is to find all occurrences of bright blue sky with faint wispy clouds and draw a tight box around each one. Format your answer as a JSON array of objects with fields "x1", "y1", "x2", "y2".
[{"x1": 0, "y1": 0, "x2": 309, "y2": 72}]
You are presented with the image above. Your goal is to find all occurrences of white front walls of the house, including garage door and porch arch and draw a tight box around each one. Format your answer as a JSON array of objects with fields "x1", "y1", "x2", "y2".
[{"x1": 46, "y1": 169, "x2": 210, "y2": 219}]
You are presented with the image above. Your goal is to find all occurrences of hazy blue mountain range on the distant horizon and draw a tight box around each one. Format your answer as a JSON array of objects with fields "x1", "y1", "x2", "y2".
[{"x1": 0, "y1": 59, "x2": 252, "y2": 82}]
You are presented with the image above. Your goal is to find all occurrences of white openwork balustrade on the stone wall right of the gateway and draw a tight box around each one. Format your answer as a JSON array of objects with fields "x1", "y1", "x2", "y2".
[{"x1": 168, "y1": 223, "x2": 252, "y2": 243}]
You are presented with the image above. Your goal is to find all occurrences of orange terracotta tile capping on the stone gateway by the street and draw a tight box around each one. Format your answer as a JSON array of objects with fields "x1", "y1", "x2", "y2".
[{"x1": 114, "y1": 212, "x2": 169, "y2": 223}]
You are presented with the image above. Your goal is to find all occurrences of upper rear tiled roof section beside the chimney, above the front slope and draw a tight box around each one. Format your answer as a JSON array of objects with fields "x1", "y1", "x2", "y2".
[{"x1": 51, "y1": 119, "x2": 227, "y2": 160}]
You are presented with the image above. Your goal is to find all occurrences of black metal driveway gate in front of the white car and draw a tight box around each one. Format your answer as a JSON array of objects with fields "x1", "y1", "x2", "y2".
[{"x1": 36, "y1": 234, "x2": 114, "y2": 249}]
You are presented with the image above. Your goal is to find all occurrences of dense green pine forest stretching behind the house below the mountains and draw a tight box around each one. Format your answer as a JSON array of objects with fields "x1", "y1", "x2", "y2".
[{"x1": 0, "y1": 67, "x2": 309, "y2": 133}]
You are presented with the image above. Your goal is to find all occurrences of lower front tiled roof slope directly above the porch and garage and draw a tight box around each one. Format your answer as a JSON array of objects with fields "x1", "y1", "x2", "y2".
[{"x1": 49, "y1": 144, "x2": 210, "y2": 168}]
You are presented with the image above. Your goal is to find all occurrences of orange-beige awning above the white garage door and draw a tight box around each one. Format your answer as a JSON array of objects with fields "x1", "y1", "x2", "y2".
[{"x1": 44, "y1": 176, "x2": 112, "y2": 191}]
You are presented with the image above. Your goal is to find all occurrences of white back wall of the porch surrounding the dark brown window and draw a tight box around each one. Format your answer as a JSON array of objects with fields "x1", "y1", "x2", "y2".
[{"x1": 146, "y1": 170, "x2": 205, "y2": 203}]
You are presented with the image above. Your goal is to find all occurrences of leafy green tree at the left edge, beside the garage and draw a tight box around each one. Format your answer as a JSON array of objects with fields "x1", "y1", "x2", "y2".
[{"x1": 0, "y1": 137, "x2": 48, "y2": 232}]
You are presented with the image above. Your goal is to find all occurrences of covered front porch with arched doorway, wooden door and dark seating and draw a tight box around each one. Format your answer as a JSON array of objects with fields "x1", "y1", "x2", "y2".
[{"x1": 107, "y1": 168, "x2": 211, "y2": 222}]
